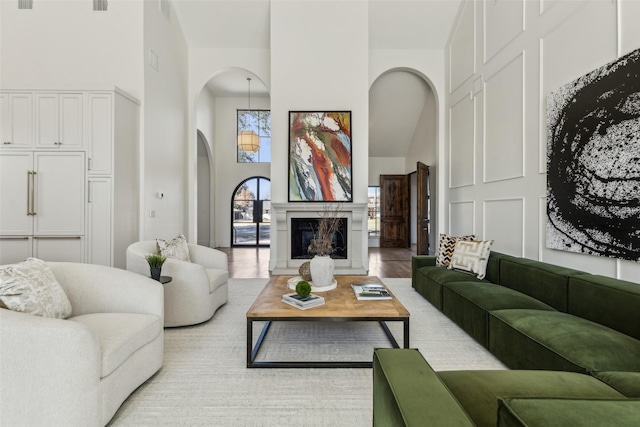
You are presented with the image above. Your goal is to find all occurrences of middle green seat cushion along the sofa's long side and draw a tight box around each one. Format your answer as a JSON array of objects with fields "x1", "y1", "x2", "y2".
[{"x1": 442, "y1": 282, "x2": 553, "y2": 347}]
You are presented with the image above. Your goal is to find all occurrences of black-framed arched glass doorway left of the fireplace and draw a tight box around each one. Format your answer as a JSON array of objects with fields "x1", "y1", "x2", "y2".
[{"x1": 231, "y1": 176, "x2": 271, "y2": 247}]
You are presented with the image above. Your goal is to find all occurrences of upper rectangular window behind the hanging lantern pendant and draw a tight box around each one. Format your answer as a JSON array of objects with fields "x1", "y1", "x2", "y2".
[{"x1": 237, "y1": 110, "x2": 271, "y2": 163}]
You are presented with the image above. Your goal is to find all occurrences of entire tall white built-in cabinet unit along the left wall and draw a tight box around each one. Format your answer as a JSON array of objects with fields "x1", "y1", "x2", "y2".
[{"x1": 0, "y1": 89, "x2": 140, "y2": 268}]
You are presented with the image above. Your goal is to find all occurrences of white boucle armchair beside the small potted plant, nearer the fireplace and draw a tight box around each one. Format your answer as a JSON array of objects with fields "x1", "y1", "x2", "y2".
[{"x1": 127, "y1": 240, "x2": 229, "y2": 327}]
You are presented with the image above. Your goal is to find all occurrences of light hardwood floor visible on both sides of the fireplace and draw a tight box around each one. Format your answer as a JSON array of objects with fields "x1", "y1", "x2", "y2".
[{"x1": 216, "y1": 247, "x2": 416, "y2": 278}]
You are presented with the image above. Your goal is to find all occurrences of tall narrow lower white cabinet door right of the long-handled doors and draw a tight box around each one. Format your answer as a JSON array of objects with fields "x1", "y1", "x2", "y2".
[{"x1": 87, "y1": 177, "x2": 113, "y2": 266}]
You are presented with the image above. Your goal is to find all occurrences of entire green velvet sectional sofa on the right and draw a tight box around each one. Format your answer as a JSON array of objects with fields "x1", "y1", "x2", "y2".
[{"x1": 373, "y1": 252, "x2": 640, "y2": 426}]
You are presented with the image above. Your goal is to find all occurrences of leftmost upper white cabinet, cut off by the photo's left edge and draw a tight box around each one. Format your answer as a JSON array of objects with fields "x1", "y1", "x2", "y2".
[{"x1": 0, "y1": 92, "x2": 33, "y2": 149}]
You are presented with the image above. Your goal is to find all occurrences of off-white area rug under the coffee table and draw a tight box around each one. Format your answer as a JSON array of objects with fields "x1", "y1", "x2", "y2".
[{"x1": 109, "y1": 279, "x2": 505, "y2": 427}]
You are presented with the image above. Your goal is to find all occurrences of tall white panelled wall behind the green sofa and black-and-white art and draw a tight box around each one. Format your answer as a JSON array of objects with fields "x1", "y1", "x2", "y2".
[{"x1": 443, "y1": 0, "x2": 640, "y2": 280}]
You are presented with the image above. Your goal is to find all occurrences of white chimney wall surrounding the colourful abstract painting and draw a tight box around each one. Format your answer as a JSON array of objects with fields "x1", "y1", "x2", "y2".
[{"x1": 270, "y1": 0, "x2": 370, "y2": 269}]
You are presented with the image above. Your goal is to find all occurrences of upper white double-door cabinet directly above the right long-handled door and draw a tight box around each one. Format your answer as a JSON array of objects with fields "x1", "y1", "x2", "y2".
[{"x1": 35, "y1": 92, "x2": 83, "y2": 150}]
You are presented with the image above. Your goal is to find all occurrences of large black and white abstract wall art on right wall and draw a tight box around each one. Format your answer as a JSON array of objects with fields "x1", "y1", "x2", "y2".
[{"x1": 547, "y1": 49, "x2": 640, "y2": 261}]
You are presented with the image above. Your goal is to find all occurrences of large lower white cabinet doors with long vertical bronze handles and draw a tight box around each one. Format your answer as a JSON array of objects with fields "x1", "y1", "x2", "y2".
[{"x1": 0, "y1": 151, "x2": 85, "y2": 264}]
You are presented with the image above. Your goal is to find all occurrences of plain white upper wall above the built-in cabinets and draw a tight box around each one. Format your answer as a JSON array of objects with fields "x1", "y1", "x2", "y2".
[{"x1": 0, "y1": 0, "x2": 144, "y2": 99}]
